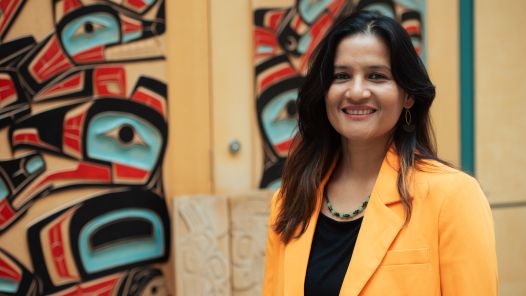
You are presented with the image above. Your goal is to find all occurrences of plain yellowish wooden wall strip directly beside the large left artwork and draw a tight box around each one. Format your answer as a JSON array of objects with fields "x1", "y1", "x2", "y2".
[{"x1": 165, "y1": 0, "x2": 212, "y2": 196}]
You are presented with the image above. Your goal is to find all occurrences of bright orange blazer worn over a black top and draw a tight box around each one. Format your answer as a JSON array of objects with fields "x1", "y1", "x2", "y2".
[{"x1": 263, "y1": 150, "x2": 498, "y2": 296}]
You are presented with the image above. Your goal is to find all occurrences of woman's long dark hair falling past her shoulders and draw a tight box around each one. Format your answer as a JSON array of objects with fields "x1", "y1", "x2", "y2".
[{"x1": 273, "y1": 11, "x2": 438, "y2": 243}]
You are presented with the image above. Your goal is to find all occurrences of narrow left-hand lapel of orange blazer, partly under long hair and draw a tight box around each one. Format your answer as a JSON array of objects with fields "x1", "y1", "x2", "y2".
[{"x1": 283, "y1": 160, "x2": 337, "y2": 296}]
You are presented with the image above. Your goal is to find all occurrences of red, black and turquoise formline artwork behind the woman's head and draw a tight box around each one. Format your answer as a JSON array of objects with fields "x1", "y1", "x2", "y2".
[{"x1": 253, "y1": 0, "x2": 425, "y2": 188}]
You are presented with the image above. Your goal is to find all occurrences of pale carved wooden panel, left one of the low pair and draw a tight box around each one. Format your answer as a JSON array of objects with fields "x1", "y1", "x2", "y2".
[{"x1": 172, "y1": 196, "x2": 231, "y2": 296}]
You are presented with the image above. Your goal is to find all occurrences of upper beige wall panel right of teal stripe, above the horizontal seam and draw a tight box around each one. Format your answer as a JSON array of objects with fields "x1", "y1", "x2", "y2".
[{"x1": 475, "y1": 0, "x2": 526, "y2": 202}]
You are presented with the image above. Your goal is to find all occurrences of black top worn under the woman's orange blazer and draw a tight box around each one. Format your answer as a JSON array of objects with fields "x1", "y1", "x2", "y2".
[{"x1": 305, "y1": 213, "x2": 362, "y2": 296}]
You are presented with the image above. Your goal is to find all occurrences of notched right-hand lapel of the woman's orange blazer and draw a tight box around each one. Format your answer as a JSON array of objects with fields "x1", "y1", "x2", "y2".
[{"x1": 340, "y1": 148, "x2": 404, "y2": 295}]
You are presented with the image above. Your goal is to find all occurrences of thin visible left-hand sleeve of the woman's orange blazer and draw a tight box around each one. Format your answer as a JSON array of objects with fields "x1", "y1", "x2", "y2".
[{"x1": 263, "y1": 191, "x2": 282, "y2": 296}]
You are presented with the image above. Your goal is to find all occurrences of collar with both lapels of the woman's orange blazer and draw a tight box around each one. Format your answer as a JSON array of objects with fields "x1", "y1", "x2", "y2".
[{"x1": 284, "y1": 147, "x2": 404, "y2": 295}]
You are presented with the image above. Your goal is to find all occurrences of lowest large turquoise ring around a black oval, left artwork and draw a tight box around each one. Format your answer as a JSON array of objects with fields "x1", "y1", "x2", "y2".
[{"x1": 79, "y1": 209, "x2": 166, "y2": 273}]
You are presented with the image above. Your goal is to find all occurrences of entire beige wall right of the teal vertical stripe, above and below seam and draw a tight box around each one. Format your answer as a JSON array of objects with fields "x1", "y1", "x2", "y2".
[{"x1": 475, "y1": 0, "x2": 526, "y2": 295}]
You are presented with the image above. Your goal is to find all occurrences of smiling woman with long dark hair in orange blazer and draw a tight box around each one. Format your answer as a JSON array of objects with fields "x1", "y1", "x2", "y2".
[{"x1": 263, "y1": 12, "x2": 498, "y2": 296}]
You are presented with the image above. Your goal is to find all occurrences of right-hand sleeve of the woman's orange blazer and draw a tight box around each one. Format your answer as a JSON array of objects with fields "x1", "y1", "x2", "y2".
[{"x1": 438, "y1": 175, "x2": 498, "y2": 296}]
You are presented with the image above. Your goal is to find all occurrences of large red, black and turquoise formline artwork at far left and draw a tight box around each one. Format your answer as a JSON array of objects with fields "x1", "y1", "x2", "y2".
[{"x1": 0, "y1": 0, "x2": 171, "y2": 295}]
